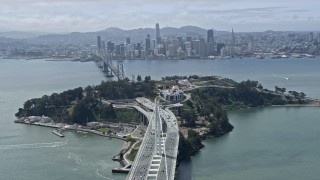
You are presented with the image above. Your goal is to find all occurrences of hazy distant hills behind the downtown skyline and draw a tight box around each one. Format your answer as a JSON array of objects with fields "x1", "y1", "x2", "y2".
[{"x1": 0, "y1": 26, "x2": 230, "y2": 45}]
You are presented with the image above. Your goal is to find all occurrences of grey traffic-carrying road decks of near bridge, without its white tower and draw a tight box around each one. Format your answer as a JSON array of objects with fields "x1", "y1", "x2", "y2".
[{"x1": 127, "y1": 98, "x2": 179, "y2": 180}]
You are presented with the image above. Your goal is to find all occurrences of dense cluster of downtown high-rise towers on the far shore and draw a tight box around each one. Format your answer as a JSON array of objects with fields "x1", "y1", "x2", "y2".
[{"x1": 97, "y1": 23, "x2": 235, "y2": 59}]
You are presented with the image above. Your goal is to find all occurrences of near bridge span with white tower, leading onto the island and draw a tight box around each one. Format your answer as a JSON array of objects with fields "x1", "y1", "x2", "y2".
[{"x1": 127, "y1": 98, "x2": 179, "y2": 180}]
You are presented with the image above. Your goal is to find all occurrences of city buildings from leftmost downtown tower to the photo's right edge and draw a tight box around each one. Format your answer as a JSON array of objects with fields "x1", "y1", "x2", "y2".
[{"x1": 97, "y1": 24, "x2": 320, "y2": 59}]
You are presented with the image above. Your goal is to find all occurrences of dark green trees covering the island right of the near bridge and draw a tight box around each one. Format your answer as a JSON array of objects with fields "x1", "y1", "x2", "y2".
[{"x1": 178, "y1": 77, "x2": 305, "y2": 160}]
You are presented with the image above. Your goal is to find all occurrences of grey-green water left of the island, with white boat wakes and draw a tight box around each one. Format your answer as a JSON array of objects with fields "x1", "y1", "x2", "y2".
[{"x1": 0, "y1": 60, "x2": 125, "y2": 180}]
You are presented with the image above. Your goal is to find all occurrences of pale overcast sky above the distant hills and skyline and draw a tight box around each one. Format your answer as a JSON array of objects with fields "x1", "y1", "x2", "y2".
[{"x1": 0, "y1": 0, "x2": 320, "y2": 32}]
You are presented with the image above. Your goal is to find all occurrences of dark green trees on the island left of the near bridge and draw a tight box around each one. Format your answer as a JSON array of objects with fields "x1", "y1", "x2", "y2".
[{"x1": 16, "y1": 77, "x2": 156, "y2": 124}]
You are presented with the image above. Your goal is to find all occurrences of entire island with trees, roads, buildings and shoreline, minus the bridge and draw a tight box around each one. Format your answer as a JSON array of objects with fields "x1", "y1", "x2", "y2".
[{"x1": 15, "y1": 75, "x2": 319, "y2": 172}]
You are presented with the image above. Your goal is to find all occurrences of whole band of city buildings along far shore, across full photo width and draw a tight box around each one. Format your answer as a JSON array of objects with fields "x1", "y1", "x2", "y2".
[{"x1": 0, "y1": 23, "x2": 320, "y2": 60}]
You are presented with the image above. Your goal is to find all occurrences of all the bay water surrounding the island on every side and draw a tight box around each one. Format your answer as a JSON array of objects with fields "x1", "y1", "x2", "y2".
[{"x1": 0, "y1": 58, "x2": 320, "y2": 180}]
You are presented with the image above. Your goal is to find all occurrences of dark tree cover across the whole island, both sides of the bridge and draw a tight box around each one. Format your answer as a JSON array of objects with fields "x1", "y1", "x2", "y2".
[{"x1": 16, "y1": 75, "x2": 319, "y2": 162}]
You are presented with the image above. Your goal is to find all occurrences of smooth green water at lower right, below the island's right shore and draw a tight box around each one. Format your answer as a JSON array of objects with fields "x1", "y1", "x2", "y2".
[{"x1": 179, "y1": 107, "x2": 320, "y2": 180}]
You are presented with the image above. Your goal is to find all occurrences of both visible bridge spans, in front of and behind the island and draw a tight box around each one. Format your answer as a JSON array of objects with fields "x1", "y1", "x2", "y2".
[{"x1": 92, "y1": 36, "x2": 179, "y2": 180}]
